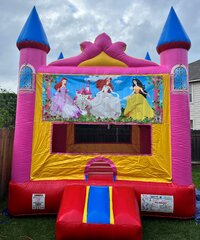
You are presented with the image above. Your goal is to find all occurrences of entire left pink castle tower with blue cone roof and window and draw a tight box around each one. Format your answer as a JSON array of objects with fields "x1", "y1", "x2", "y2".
[{"x1": 12, "y1": 7, "x2": 50, "y2": 182}]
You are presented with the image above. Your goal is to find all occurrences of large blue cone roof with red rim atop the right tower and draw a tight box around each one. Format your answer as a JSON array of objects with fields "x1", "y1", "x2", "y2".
[{"x1": 157, "y1": 7, "x2": 191, "y2": 54}]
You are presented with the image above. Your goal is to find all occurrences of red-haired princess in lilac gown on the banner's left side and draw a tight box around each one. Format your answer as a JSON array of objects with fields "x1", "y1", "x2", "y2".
[{"x1": 50, "y1": 78, "x2": 81, "y2": 118}]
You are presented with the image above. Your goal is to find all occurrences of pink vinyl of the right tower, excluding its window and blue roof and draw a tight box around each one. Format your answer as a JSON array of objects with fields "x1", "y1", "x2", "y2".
[{"x1": 160, "y1": 48, "x2": 192, "y2": 185}]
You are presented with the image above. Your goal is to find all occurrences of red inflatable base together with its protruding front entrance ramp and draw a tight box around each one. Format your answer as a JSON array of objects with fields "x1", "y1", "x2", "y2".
[{"x1": 8, "y1": 180, "x2": 195, "y2": 240}]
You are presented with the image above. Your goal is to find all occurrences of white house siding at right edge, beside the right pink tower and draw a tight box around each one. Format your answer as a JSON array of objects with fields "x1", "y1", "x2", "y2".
[{"x1": 190, "y1": 81, "x2": 200, "y2": 130}]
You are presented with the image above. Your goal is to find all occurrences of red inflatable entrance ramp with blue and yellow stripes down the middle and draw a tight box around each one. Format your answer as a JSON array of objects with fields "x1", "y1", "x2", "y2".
[{"x1": 56, "y1": 185, "x2": 142, "y2": 240}]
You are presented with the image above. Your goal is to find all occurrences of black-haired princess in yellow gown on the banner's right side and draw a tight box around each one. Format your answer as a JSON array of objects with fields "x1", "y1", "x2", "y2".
[{"x1": 124, "y1": 78, "x2": 154, "y2": 121}]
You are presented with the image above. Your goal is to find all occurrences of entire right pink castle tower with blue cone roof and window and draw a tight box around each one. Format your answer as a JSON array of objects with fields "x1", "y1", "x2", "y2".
[{"x1": 157, "y1": 7, "x2": 192, "y2": 185}]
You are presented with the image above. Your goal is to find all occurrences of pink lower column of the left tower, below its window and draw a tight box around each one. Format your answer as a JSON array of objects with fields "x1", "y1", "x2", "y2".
[{"x1": 12, "y1": 92, "x2": 35, "y2": 182}]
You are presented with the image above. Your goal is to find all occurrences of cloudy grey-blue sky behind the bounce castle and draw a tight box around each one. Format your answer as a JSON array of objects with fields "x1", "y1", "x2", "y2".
[{"x1": 0, "y1": 0, "x2": 200, "y2": 92}]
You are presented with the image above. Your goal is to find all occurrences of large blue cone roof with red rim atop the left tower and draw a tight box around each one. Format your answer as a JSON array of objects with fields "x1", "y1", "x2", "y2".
[{"x1": 17, "y1": 7, "x2": 50, "y2": 53}]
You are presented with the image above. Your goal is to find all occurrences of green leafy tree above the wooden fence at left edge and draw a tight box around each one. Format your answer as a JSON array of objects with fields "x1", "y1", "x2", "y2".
[{"x1": 0, "y1": 88, "x2": 17, "y2": 128}]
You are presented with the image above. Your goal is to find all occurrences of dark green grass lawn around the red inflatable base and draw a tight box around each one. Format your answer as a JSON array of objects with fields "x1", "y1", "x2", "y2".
[{"x1": 0, "y1": 166, "x2": 200, "y2": 240}]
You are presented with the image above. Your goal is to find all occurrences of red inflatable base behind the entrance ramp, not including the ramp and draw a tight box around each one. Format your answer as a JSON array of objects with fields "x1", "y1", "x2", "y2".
[{"x1": 8, "y1": 180, "x2": 196, "y2": 218}]
